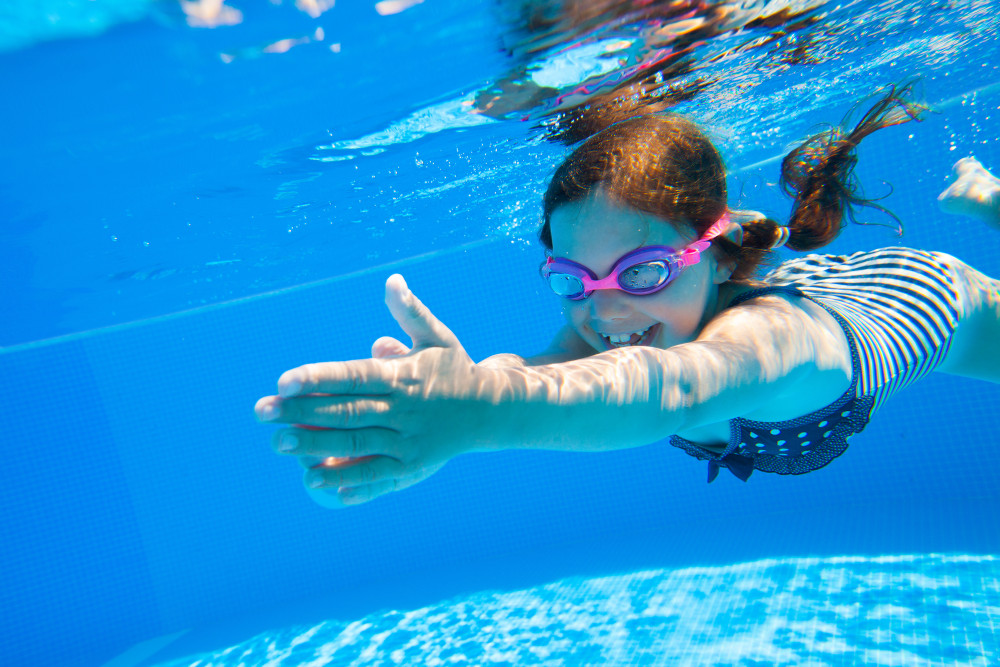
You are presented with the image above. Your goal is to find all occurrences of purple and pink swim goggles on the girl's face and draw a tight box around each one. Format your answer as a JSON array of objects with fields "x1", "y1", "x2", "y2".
[{"x1": 540, "y1": 213, "x2": 729, "y2": 301}]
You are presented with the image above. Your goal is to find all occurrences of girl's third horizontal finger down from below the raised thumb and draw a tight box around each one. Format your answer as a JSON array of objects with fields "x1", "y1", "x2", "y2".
[{"x1": 271, "y1": 428, "x2": 403, "y2": 459}]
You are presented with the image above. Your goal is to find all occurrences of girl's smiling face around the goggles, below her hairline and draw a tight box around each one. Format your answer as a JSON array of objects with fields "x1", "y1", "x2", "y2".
[{"x1": 549, "y1": 189, "x2": 729, "y2": 352}]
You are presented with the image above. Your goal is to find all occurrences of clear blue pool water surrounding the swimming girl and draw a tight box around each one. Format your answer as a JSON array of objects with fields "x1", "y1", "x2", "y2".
[{"x1": 0, "y1": 0, "x2": 1000, "y2": 667}]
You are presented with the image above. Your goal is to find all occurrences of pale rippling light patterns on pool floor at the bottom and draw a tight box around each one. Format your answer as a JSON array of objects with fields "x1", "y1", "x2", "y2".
[{"x1": 161, "y1": 554, "x2": 1000, "y2": 667}]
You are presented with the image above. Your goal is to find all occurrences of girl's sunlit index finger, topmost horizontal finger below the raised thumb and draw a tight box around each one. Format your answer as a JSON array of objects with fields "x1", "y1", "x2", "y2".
[{"x1": 278, "y1": 359, "x2": 398, "y2": 397}]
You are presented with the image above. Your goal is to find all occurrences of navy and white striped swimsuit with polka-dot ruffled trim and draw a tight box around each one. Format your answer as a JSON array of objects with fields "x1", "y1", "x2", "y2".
[{"x1": 670, "y1": 248, "x2": 961, "y2": 482}]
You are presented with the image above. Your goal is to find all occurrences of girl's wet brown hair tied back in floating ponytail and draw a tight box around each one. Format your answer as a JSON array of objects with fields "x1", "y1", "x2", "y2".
[{"x1": 539, "y1": 83, "x2": 927, "y2": 281}]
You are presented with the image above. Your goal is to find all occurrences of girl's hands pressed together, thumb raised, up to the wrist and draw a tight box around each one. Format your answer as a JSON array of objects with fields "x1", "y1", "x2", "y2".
[{"x1": 255, "y1": 275, "x2": 495, "y2": 507}]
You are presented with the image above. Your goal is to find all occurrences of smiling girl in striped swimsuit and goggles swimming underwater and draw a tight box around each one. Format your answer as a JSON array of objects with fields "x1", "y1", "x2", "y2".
[{"x1": 256, "y1": 89, "x2": 1000, "y2": 507}]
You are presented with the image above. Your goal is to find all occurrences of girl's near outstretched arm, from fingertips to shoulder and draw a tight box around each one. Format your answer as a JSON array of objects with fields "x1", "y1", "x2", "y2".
[{"x1": 256, "y1": 276, "x2": 849, "y2": 505}]
